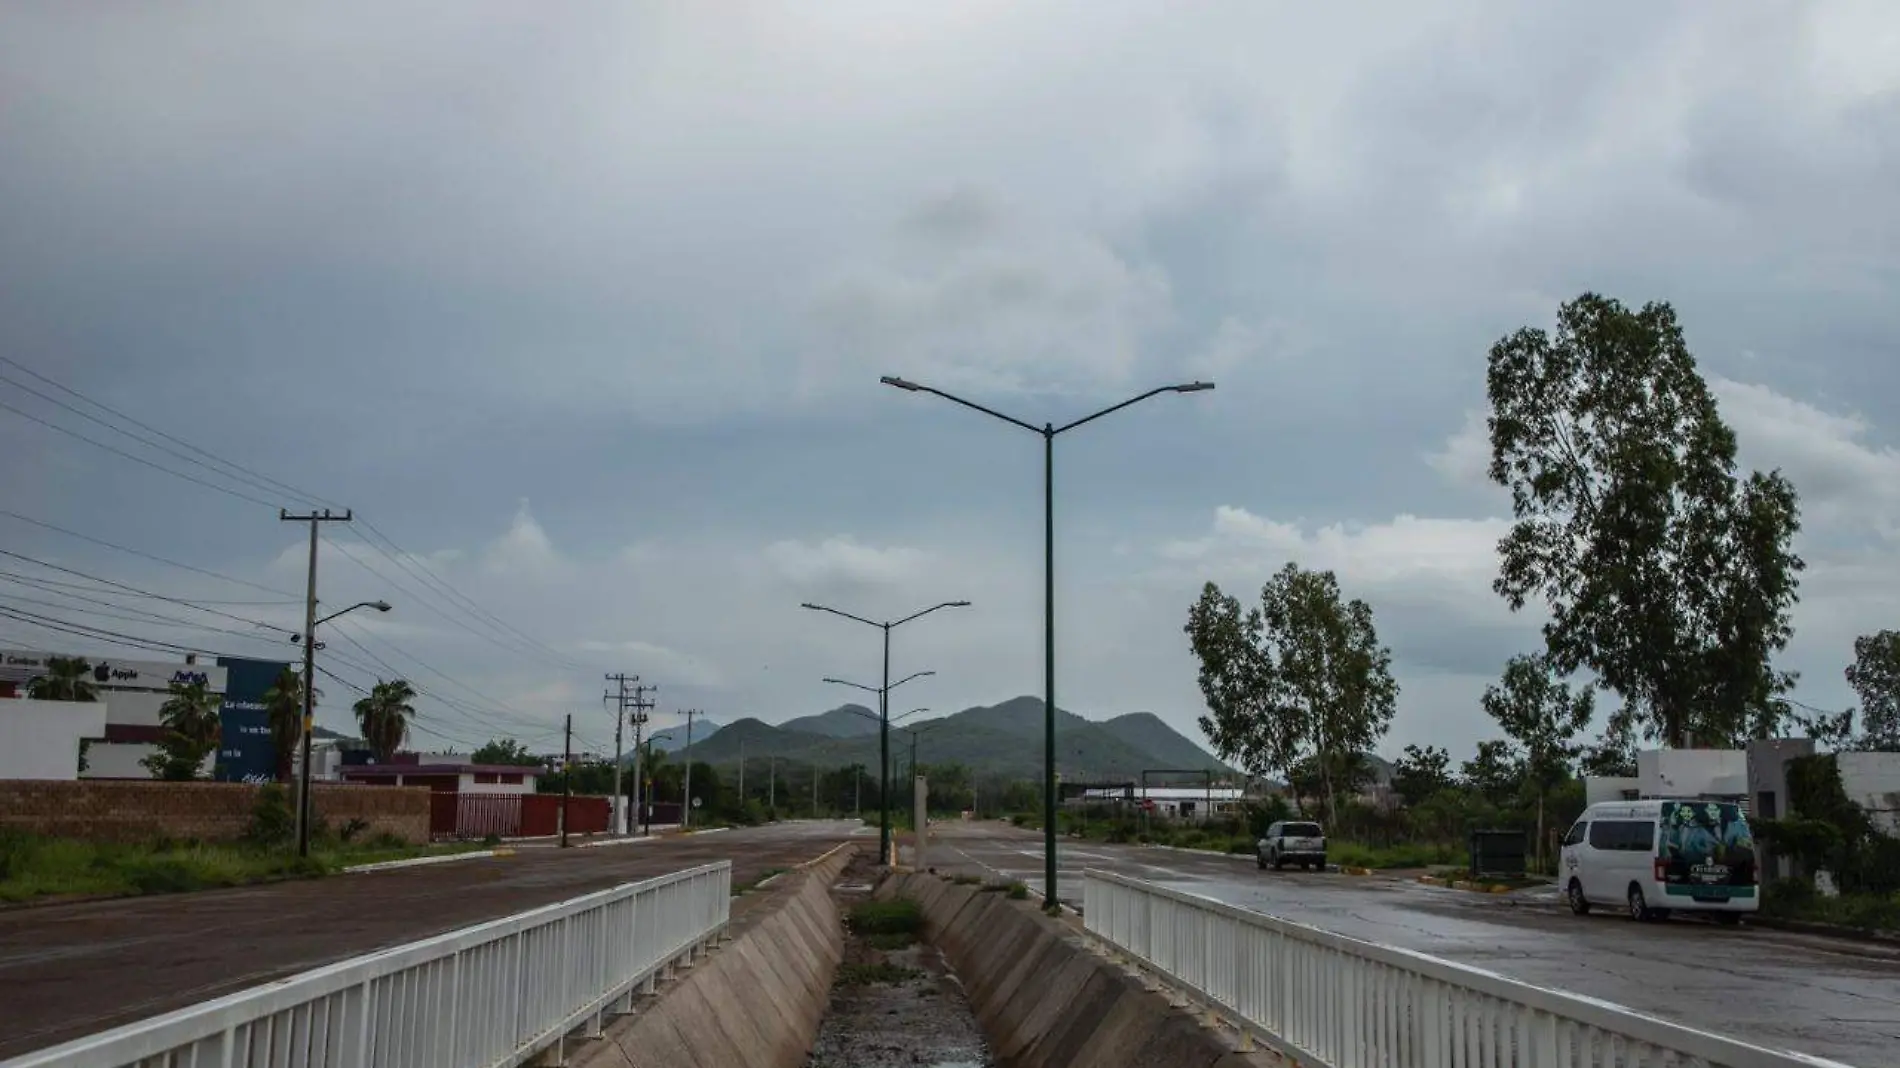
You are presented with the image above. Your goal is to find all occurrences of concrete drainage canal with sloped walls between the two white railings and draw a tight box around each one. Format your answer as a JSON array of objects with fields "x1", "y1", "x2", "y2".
[{"x1": 568, "y1": 848, "x2": 1279, "y2": 1068}]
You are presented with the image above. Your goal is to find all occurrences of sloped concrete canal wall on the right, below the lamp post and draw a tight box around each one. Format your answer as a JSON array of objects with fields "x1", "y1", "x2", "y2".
[{"x1": 876, "y1": 874, "x2": 1284, "y2": 1068}]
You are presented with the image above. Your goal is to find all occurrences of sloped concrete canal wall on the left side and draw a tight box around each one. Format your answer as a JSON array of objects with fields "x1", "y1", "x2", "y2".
[{"x1": 570, "y1": 846, "x2": 857, "y2": 1068}]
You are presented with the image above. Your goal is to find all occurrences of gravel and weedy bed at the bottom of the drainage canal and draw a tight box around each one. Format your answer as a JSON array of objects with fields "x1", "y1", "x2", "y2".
[{"x1": 806, "y1": 861, "x2": 996, "y2": 1068}]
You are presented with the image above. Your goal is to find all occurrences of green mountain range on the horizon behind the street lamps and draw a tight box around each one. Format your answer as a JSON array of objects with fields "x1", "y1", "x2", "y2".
[{"x1": 676, "y1": 697, "x2": 1237, "y2": 781}]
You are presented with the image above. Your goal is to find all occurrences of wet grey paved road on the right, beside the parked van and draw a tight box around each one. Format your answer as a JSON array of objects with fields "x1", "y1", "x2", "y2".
[{"x1": 929, "y1": 823, "x2": 1900, "y2": 1068}]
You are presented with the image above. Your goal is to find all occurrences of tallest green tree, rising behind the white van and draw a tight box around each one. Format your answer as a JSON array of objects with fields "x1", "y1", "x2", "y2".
[{"x1": 1488, "y1": 293, "x2": 1803, "y2": 745}]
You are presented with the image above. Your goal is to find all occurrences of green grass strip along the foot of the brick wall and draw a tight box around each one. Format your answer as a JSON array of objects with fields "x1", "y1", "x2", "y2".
[{"x1": 0, "y1": 832, "x2": 477, "y2": 903}]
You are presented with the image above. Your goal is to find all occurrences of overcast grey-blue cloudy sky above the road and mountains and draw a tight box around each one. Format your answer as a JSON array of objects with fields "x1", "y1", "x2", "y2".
[{"x1": 0, "y1": 0, "x2": 1900, "y2": 754}]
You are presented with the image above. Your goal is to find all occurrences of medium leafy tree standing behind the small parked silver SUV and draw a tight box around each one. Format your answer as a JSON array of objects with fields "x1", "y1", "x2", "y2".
[{"x1": 1186, "y1": 563, "x2": 1398, "y2": 817}]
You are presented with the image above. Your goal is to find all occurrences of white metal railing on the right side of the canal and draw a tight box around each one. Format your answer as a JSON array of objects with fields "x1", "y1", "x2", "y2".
[{"x1": 1083, "y1": 870, "x2": 1845, "y2": 1068}]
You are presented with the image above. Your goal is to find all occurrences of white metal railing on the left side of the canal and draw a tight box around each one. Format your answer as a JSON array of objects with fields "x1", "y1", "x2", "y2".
[{"x1": 0, "y1": 861, "x2": 732, "y2": 1068}]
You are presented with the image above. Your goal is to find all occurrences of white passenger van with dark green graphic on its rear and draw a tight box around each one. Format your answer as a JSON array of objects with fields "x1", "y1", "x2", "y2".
[{"x1": 1560, "y1": 800, "x2": 1761, "y2": 924}]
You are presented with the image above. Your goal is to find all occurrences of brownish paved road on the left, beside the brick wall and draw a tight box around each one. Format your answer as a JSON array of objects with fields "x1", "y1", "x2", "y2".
[{"x1": 0, "y1": 823, "x2": 863, "y2": 1058}]
